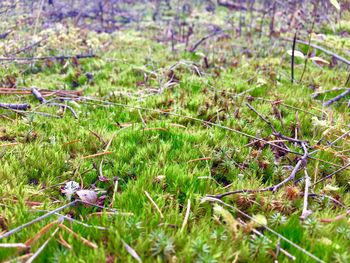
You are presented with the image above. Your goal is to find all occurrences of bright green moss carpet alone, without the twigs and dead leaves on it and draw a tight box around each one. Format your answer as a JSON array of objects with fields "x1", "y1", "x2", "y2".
[{"x1": 0, "y1": 14, "x2": 350, "y2": 262}]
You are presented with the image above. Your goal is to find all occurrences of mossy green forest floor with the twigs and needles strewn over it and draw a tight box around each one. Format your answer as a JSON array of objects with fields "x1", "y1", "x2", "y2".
[{"x1": 0, "y1": 5, "x2": 350, "y2": 262}]
